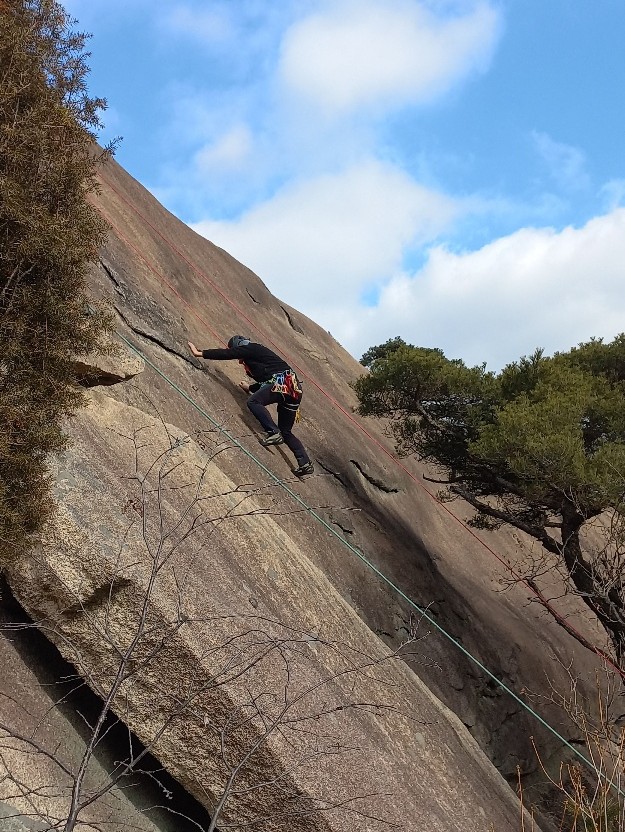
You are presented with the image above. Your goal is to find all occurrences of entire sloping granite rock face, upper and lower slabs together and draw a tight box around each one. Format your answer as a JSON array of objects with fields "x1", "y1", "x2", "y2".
[{"x1": 0, "y1": 156, "x2": 605, "y2": 832}]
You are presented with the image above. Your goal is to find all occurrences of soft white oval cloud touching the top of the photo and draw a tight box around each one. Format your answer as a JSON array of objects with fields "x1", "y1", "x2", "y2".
[{"x1": 280, "y1": 0, "x2": 500, "y2": 113}]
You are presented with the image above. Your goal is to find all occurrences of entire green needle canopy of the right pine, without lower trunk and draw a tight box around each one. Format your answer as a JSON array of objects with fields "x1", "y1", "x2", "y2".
[{"x1": 354, "y1": 336, "x2": 625, "y2": 518}]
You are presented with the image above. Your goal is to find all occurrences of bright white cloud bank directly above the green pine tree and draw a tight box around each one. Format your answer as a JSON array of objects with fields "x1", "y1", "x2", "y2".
[{"x1": 342, "y1": 208, "x2": 625, "y2": 369}]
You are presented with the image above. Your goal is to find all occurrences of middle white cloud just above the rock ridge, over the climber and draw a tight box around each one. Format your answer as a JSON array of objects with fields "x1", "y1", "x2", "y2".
[{"x1": 194, "y1": 161, "x2": 459, "y2": 306}]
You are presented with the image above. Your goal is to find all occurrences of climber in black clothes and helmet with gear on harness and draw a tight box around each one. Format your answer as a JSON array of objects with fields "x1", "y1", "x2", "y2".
[{"x1": 188, "y1": 335, "x2": 314, "y2": 477}]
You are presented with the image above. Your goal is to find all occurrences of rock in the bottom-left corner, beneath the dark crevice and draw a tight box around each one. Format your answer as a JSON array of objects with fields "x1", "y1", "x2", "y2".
[{"x1": 0, "y1": 588, "x2": 188, "y2": 832}]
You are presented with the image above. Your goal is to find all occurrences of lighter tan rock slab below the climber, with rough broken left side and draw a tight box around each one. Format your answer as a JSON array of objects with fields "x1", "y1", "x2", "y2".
[{"x1": 8, "y1": 391, "x2": 532, "y2": 832}]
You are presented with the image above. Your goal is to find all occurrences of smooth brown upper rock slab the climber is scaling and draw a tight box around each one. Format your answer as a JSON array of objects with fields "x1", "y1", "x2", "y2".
[{"x1": 93, "y1": 158, "x2": 607, "y2": 781}]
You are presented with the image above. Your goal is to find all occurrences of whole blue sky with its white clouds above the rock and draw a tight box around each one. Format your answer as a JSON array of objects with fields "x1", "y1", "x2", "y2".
[{"x1": 65, "y1": 0, "x2": 625, "y2": 369}]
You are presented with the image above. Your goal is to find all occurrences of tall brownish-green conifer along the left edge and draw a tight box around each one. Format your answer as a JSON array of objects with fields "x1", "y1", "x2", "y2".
[{"x1": 0, "y1": 0, "x2": 108, "y2": 559}]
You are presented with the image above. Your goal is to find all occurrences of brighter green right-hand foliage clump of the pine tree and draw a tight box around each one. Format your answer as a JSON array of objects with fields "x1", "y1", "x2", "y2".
[{"x1": 469, "y1": 360, "x2": 625, "y2": 518}]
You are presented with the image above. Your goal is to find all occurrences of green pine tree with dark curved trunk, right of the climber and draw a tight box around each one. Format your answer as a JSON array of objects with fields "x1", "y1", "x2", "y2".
[{"x1": 355, "y1": 335, "x2": 625, "y2": 661}]
